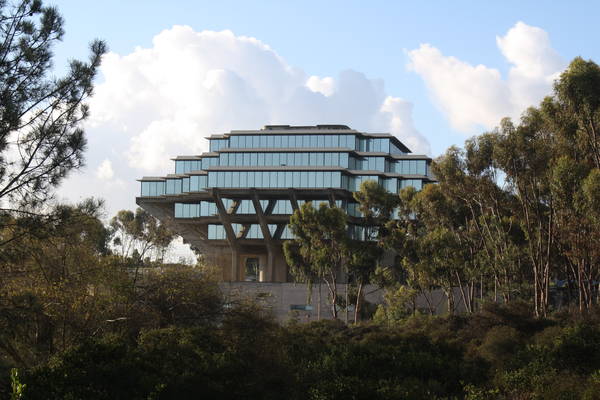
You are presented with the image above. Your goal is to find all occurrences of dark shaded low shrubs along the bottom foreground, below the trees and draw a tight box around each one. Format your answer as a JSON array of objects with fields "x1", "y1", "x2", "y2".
[{"x1": 8, "y1": 296, "x2": 600, "y2": 399}]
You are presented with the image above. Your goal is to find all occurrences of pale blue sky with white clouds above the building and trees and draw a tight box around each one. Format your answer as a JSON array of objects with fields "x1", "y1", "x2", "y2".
[{"x1": 49, "y1": 0, "x2": 600, "y2": 260}]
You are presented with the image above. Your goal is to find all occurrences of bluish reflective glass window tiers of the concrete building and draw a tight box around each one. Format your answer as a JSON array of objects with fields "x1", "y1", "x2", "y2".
[{"x1": 141, "y1": 126, "x2": 433, "y2": 240}]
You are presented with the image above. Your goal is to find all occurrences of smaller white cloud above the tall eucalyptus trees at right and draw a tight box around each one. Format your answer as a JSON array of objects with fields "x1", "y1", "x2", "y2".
[{"x1": 408, "y1": 22, "x2": 565, "y2": 134}]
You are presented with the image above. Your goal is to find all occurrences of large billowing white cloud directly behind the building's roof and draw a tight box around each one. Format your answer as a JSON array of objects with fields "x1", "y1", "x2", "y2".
[{"x1": 86, "y1": 26, "x2": 428, "y2": 173}]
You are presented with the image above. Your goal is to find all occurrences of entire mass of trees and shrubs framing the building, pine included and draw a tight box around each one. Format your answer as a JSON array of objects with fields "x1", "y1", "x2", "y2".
[{"x1": 0, "y1": 0, "x2": 600, "y2": 400}]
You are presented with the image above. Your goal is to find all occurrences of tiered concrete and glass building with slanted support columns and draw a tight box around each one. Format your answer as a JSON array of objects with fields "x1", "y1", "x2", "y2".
[{"x1": 136, "y1": 125, "x2": 433, "y2": 282}]
